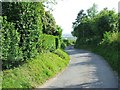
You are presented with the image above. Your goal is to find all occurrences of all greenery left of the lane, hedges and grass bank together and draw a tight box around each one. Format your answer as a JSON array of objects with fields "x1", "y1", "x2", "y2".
[{"x1": 0, "y1": 0, "x2": 69, "y2": 88}]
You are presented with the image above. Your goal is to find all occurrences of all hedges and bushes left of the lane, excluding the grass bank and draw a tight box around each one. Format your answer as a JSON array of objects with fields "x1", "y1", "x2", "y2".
[{"x1": 0, "y1": 2, "x2": 62, "y2": 69}]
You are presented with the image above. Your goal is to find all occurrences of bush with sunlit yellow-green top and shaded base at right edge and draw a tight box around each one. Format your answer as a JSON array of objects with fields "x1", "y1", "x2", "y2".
[{"x1": 98, "y1": 31, "x2": 120, "y2": 75}]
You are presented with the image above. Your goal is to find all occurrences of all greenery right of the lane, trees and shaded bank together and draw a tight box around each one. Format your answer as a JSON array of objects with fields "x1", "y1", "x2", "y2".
[{"x1": 72, "y1": 4, "x2": 120, "y2": 76}]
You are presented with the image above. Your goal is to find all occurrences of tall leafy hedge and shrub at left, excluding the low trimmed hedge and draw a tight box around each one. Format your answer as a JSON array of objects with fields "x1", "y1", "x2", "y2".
[{"x1": 0, "y1": 2, "x2": 44, "y2": 69}]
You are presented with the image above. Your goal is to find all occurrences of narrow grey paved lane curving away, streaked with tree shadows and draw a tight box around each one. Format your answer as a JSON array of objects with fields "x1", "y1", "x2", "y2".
[{"x1": 41, "y1": 47, "x2": 118, "y2": 88}]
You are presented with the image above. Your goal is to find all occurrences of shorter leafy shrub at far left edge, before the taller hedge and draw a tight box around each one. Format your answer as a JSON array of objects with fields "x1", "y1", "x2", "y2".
[{"x1": 0, "y1": 17, "x2": 23, "y2": 68}]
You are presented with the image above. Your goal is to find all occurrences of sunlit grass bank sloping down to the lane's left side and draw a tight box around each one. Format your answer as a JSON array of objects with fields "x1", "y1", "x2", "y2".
[{"x1": 2, "y1": 49, "x2": 70, "y2": 88}]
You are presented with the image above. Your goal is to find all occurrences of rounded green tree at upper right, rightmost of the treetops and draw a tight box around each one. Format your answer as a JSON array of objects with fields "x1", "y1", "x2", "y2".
[{"x1": 96, "y1": 8, "x2": 118, "y2": 38}]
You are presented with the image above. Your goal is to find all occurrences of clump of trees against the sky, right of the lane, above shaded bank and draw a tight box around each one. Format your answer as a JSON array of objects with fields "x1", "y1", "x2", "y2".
[{"x1": 72, "y1": 4, "x2": 118, "y2": 44}]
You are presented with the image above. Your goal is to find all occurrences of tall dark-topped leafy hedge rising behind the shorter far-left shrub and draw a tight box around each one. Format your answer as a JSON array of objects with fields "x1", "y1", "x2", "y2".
[{"x1": 2, "y1": 2, "x2": 44, "y2": 59}]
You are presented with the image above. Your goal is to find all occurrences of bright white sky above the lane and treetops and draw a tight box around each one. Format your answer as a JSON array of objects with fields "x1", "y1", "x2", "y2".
[{"x1": 52, "y1": 0, "x2": 120, "y2": 34}]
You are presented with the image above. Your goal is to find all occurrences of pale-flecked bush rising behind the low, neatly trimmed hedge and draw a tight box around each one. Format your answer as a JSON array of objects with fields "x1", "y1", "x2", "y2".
[{"x1": 42, "y1": 11, "x2": 62, "y2": 38}]
